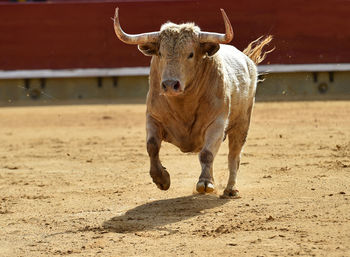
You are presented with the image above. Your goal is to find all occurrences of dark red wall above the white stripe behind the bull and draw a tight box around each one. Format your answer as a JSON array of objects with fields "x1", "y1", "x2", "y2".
[{"x1": 0, "y1": 0, "x2": 350, "y2": 70}]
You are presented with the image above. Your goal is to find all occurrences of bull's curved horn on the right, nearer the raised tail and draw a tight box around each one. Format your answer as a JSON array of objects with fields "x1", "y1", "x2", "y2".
[{"x1": 199, "y1": 9, "x2": 233, "y2": 44}]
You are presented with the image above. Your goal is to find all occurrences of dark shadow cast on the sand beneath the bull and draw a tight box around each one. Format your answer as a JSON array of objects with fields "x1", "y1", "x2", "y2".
[{"x1": 102, "y1": 195, "x2": 228, "y2": 233}]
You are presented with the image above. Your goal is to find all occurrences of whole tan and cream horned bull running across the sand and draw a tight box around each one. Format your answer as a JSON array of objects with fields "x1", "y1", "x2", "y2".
[{"x1": 114, "y1": 8, "x2": 272, "y2": 198}]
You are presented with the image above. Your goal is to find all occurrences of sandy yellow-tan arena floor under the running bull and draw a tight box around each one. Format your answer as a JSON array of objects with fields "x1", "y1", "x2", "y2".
[{"x1": 0, "y1": 102, "x2": 350, "y2": 256}]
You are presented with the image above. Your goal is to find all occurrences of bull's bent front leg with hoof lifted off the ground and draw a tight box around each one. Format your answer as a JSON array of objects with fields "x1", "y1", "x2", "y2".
[{"x1": 146, "y1": 114, "x2": 170, "y2": 190}]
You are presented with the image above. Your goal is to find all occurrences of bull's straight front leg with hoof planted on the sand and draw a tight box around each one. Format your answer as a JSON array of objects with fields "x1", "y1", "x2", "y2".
[{"x1": 196, "y1": 116, "x2": 225, "y2": 193}]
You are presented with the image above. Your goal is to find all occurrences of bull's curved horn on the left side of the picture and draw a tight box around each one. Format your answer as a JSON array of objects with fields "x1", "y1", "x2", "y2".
[{"x1": 114, "y1": 7, "x2": 159, "y2": 45}]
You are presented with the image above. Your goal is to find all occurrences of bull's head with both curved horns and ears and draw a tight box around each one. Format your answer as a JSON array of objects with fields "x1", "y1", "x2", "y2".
[{"x1": 114, "y1": 8, "x2": 233, "y2": 96}]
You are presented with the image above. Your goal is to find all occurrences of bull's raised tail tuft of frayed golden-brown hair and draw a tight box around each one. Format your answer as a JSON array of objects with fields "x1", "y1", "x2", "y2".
[{"x1": 243, "y1": 35, "x2": 275, "y2": 64}]
